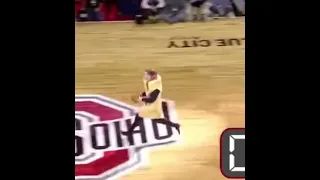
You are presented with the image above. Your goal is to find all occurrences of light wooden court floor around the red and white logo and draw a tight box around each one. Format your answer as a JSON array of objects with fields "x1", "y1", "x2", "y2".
[{"x1": 75, "y1": 19, "x2": 245, "y2": 180}]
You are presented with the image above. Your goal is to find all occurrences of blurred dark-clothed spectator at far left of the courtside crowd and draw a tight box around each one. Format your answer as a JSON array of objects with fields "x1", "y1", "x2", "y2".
[{"x1": 85, "y1": 0, "x2": 103, "y2": 21}]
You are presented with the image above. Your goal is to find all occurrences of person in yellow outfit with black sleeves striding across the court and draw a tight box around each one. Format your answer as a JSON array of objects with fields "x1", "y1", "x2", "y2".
[{"x1": 122, "y1": 70, "x2": 180, "y2": 135}]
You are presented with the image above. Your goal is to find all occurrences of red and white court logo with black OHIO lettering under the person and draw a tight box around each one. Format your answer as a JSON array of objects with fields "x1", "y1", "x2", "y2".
[{"x1": 75, "y1": 95, "x2": 179, "y2": 180}]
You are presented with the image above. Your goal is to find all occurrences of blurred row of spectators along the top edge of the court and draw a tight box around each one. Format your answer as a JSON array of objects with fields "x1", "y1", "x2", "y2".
[{"x1": 75, "y1": 0, "x2": 245, "y2": 24}]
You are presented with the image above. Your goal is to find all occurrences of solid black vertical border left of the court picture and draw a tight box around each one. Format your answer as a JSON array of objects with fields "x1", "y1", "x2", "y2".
[{"x1": 1, "y1": 0, "x2": 75, "y2": 180}]
